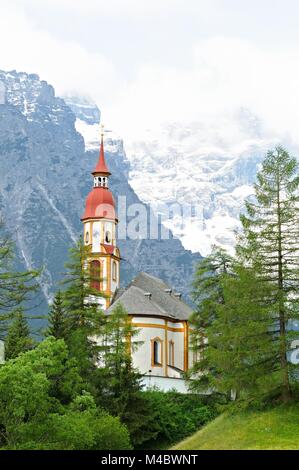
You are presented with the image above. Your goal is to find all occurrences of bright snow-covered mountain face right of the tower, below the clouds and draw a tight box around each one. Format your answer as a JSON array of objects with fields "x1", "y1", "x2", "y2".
[{"x1": 76, "y1": 109, "x2": 277, "y2": 255}]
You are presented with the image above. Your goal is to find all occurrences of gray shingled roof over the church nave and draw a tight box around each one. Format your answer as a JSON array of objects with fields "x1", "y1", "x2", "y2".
[{"x1": 106, "y1": 272, "x2": 192, "y2": 320}]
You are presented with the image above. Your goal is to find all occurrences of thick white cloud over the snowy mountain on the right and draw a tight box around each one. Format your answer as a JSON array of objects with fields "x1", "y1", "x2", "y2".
[{"x1": 108, "y1": 37, "x2": 299, "y2": 148}]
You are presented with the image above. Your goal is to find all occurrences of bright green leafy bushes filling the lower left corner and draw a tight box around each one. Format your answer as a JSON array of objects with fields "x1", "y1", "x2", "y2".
[{"x1": 0, "y1": 337, "x2": 130, "y2": 450}]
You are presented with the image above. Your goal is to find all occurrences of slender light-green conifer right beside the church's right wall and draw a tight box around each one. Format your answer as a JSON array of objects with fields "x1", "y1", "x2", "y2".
[{"x1": 187, "y1": 246, "x2": 233, "y2": 392}]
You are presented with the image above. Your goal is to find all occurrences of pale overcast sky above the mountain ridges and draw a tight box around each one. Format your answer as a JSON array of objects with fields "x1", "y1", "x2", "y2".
[{"x1": 0, "y1": 0, "x2": 299, "y2": 144}]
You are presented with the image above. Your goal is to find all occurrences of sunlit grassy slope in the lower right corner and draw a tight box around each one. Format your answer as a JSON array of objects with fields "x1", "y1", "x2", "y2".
[{"x1": 174, "y1": 405, "x2": 299, "y2": 450}]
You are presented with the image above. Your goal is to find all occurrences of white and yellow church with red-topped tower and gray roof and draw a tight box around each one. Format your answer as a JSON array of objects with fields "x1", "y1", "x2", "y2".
[{"x1": 81, "y1": 132, "x2": 193, "y2": 393}]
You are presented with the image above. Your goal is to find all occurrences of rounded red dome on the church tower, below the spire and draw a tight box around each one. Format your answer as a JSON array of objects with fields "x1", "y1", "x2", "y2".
[{"x1": 81, "y1": 187, "x2": 116, "y2": 220}]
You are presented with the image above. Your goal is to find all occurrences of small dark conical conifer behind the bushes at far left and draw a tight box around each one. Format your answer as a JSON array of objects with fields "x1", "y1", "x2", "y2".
[{"x1": 5, "y1": 308, "x2": 33, "y2": 359}]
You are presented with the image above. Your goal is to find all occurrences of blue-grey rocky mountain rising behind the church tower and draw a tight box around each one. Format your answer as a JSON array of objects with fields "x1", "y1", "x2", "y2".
[{"x1": 0, "y1": 71, "x2": 200, "y2": 320}]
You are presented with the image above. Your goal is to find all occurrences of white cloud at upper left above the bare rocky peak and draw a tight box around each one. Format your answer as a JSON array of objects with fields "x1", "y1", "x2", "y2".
[{"x1": 0, "y1": 2, "x2": 118, "y2": 103}]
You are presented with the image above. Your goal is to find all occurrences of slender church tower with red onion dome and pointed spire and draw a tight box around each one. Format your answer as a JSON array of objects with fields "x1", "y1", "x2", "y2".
[{"x1": 81, "y1": 131, "x2": 120, "y2": 309}]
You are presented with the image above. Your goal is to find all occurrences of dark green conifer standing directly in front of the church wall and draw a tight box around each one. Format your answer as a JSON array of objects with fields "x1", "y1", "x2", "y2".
[{"x1": 97, "y1": 304, "x2": 152, "y2": 444}]
